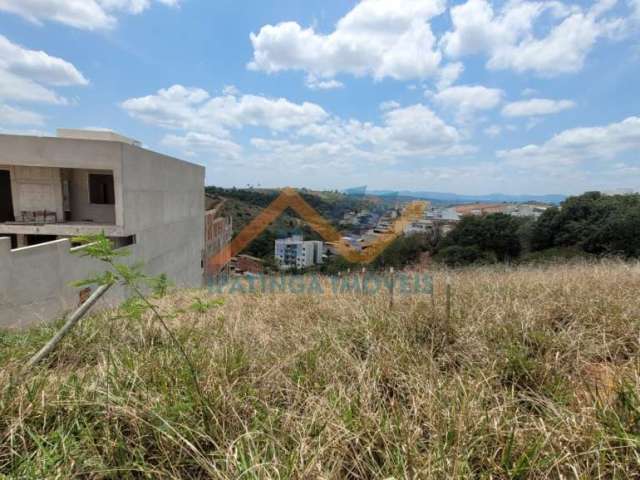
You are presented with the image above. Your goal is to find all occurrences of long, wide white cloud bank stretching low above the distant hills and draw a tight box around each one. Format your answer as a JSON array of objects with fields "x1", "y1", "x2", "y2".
[{"x1": 122, "y1": 85, "x2": 474, "y2": 171}]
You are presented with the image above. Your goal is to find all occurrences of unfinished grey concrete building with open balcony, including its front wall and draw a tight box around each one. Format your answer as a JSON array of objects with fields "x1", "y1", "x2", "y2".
[{"x1": 0, "y1": 130, "x2": 205, "y2": 327}]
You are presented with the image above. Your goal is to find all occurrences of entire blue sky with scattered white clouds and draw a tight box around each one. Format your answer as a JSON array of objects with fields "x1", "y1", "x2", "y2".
[{"x1": 0, "y1": 0, "x2": 640, "y2": 194}]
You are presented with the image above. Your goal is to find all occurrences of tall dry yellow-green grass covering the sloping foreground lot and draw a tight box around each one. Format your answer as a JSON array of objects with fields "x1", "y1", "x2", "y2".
[{"x1": 0, "y1": 262, "x2": 640, "y2": 479}]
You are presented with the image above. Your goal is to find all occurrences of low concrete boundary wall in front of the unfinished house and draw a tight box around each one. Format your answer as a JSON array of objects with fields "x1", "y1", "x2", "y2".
[{"x1": 0, "y1": 238, "x2": 137, "y2": 328}]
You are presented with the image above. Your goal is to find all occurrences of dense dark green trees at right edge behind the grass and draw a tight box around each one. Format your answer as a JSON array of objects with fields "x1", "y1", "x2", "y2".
[{"x1": 436, "y1": 192, "x2": 640, "y2": 265}]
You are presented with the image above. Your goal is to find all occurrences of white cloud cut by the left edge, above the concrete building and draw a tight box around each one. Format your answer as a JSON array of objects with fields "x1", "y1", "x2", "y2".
[{"x1": 0, "y1": 35, "x2": 89, "y2": 104}]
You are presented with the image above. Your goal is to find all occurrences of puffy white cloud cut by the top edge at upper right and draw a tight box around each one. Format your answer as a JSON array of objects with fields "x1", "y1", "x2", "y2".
[{"x1": 441, "y1": 0, "x2": 625, "y2": 76}]
